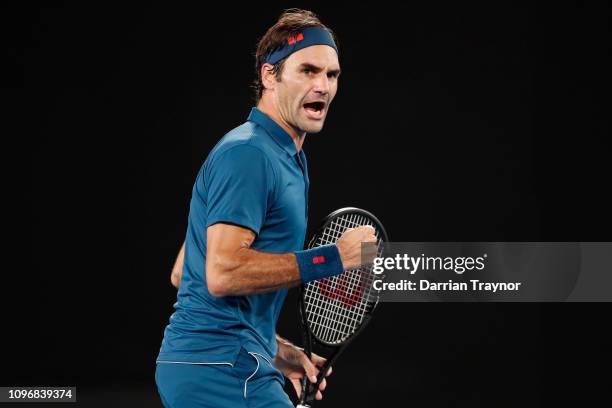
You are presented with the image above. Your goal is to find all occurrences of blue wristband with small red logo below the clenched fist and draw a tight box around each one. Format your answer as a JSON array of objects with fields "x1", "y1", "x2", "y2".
[{"x1": 294, "y1": 244, "x2": 344, "y2": 283}]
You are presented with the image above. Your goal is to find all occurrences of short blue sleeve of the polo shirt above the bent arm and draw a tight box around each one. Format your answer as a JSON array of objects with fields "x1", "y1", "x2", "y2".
[{"x1": 204, "y1": 144, "x2": 274, "y2": 234}]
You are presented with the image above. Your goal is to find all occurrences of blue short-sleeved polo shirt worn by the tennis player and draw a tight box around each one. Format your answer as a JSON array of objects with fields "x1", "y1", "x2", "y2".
[{"x1": 157, "y1": 108, "x2": 309, "y2": 364}]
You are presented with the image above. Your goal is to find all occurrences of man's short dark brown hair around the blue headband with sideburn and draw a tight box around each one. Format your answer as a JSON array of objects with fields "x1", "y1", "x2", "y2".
[{"x1": 253, "y1": 8, "x2": 338, "y2": 102}]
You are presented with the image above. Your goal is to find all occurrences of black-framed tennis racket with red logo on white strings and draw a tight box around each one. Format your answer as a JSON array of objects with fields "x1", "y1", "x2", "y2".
[{"x1": 297, "y1": 207, "x2": 388, "y2": 408}]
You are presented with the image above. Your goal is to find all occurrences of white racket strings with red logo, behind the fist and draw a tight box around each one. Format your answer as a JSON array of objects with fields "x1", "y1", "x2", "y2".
[{"x1": 304, "y1": 213, "x2": 382, "y2": 344}]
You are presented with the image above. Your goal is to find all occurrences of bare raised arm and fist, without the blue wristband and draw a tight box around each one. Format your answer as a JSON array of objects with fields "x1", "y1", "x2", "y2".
[{"x1": 206, "y1": 223, "x2": 376, "y2": 296}]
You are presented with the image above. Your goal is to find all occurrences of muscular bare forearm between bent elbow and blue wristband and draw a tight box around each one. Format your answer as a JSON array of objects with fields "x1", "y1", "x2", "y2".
[{"x1": 206, "y1": 247, "x2": 301, "y2": 296}]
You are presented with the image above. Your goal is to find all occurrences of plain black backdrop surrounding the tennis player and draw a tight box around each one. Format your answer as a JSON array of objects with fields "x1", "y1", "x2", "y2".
[{"x1": 10, "y1": 2, "x2": 612, "y2": 407}]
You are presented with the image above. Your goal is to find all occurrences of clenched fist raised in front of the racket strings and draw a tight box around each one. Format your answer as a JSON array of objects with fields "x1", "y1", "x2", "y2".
[{"x1": 336, "y1": 225, "x2": 378, "y2": 271}]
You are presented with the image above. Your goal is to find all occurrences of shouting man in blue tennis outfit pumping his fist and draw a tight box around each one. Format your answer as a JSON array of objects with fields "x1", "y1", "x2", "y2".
[{"x1": 156, "y1": 9, "x2": 376, "y2": 408}]
